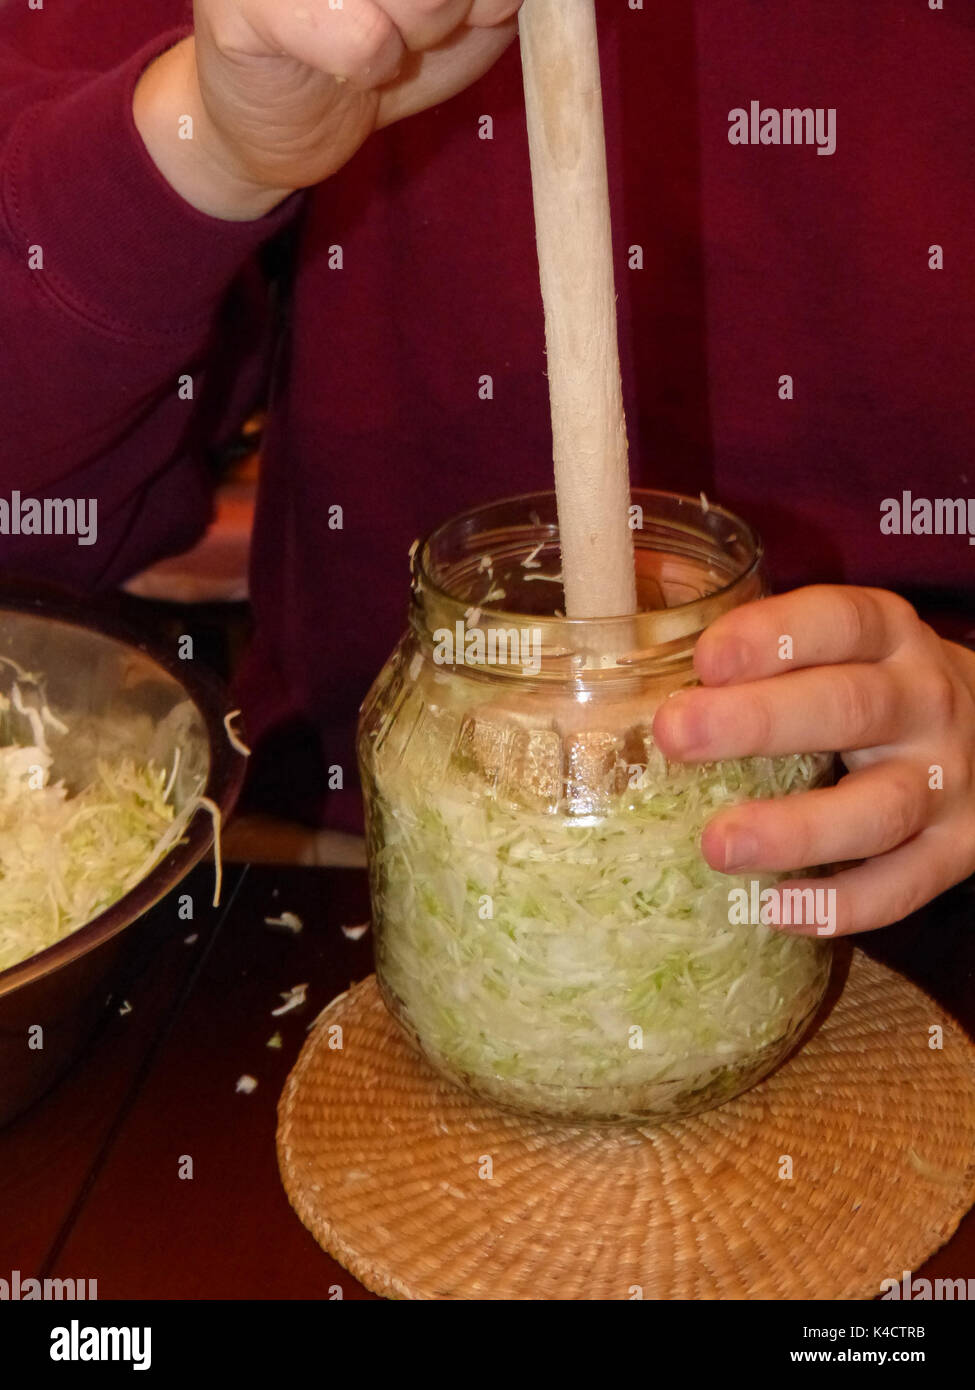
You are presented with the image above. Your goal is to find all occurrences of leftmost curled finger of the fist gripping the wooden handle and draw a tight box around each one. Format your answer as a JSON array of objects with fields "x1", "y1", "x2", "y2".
[{"x1": 239, "y1": 0, "x2": 406, "y2": 88}]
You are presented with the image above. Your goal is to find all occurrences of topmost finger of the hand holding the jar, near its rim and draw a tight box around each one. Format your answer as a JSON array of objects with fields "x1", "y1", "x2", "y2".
[{"x1": 694, "y1": 584, "x2": 919, "y2": 685}]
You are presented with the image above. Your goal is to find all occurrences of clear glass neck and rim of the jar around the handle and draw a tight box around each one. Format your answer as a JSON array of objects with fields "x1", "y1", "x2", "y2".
[{"x1": 410, "y1": 488, "x2": 765, "y2": 684}]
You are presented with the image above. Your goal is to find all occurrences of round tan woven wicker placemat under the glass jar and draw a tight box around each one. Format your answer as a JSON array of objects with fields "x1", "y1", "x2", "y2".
[{"x1": 278, "y1": 951, "x2": 975, "y2": 1300}]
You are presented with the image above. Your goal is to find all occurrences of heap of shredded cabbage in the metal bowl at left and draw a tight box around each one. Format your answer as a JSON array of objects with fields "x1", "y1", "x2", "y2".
[{"x1": 0, "y1": 655, "x2": 221, "y2": 972}]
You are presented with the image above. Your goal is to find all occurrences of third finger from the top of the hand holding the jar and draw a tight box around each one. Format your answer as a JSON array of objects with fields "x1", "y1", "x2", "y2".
[{"x1": 701, "y1": 762, "x2": 932, "y2": 873}]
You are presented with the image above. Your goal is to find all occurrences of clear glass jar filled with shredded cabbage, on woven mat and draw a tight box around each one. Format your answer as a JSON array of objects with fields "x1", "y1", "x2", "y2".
[{"x1": 359, "y1": 489, "x2": 832, "y2": 1123}]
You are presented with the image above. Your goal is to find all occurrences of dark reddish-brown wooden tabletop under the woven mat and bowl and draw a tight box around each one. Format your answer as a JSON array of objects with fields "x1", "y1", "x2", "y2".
[{"x1": 0, "y1": 867, "x2": 975, "y2": 1300}]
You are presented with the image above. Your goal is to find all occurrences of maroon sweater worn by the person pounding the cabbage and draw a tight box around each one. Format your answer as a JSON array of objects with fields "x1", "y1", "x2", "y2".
[{"x1": 0, "y1": 0, "x2": 975, "y2": 821}]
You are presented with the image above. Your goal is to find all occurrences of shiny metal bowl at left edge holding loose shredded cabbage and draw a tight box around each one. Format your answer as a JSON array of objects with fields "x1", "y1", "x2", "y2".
[{"x1": 0, "y1": 599, "x2": 246, "y2": 1125}]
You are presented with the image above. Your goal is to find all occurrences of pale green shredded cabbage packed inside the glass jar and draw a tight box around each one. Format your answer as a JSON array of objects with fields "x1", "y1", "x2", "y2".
[{"x1": 369, "y1": 692, "x2": 829, "y2": 1119}]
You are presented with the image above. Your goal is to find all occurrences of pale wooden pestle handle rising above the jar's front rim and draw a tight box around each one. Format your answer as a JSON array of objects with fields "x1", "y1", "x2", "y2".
[{"x1": 519, "y1": 0, "x2": 637, "y2": 617}]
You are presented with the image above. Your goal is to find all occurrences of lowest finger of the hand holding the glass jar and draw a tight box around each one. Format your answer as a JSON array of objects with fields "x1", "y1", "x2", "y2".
[{"x1": 751, "y1": 826, "x2": 975, "y2": 937}]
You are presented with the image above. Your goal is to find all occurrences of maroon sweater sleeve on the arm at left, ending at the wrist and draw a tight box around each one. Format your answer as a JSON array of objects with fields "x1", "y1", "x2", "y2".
[{"x1": 0, "y1": 31, "x2": 300, "y2": 588}]
